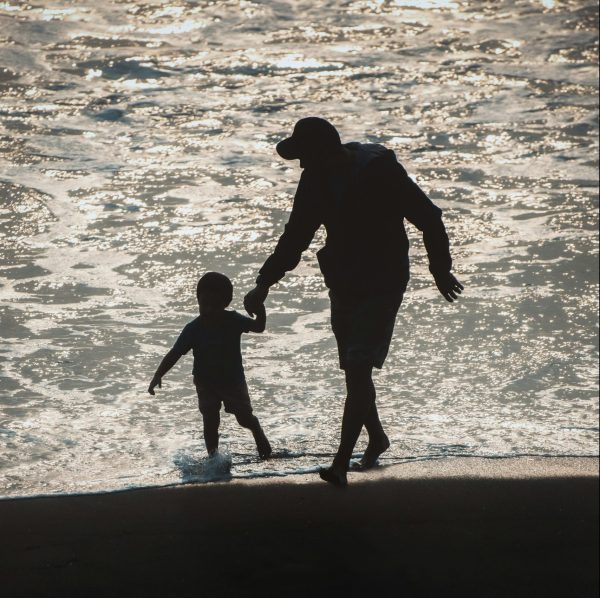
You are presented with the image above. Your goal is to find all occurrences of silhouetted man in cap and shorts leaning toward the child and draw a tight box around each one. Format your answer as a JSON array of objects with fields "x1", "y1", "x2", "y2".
[{"x1": 244, "y1": 117, "x2": 463, "y2": 486}]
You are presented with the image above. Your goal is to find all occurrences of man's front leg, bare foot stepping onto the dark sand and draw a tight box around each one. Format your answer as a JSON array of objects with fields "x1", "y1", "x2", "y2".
[{"x1": 321, "y1": 365, "x2": 372, "y2": 486}]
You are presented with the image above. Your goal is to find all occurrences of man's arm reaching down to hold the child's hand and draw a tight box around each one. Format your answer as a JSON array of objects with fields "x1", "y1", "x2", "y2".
[{"x1": 244, "y1": 173, "x2": 321, "y2": 315}]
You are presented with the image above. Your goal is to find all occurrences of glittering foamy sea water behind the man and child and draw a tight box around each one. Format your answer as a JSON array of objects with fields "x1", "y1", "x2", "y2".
[{"x1": 0, "y1": 0, "x2": 598, "y2": 496}]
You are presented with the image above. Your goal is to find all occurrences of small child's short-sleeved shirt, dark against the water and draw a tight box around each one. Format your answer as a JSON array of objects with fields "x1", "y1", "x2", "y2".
[{"x1": 173, "y1": 310, "x2": 254, "y2": 384}]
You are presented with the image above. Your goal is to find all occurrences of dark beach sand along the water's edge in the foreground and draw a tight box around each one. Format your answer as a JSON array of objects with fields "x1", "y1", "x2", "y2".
[{"x1": 0, "y1": 458, "x2": 598, "y2": 598}]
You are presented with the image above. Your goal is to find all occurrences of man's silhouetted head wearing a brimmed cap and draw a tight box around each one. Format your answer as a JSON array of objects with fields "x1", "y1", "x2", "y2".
[{"x1": 276, "y1": 116, "x2": 343, "y2": 168}]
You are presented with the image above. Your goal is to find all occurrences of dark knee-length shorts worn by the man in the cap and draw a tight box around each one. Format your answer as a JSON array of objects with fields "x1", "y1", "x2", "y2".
[{"x1": 329, "y1": 289, "x2": 404, "y2": 370}]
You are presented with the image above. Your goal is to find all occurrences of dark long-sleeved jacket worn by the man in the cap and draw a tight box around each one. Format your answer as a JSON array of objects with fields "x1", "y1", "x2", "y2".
[{"x1": 257, "y1": 143, "x2": 452, "y2": 293}]
